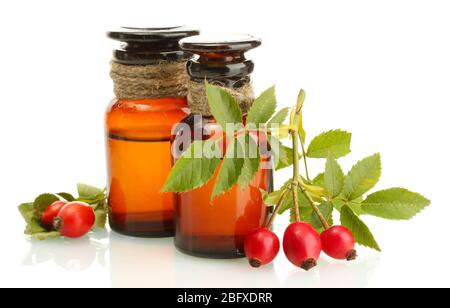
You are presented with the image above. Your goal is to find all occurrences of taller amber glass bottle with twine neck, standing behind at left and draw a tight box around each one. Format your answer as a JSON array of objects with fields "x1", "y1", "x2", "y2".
[{"x1": 106, "y1": 27, "x2": 198, "y2": 237}]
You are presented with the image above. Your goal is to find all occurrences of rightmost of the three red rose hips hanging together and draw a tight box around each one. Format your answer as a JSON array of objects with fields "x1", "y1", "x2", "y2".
[{"x1": 320, "y1": 226, "x2": 357, "y2": 261}]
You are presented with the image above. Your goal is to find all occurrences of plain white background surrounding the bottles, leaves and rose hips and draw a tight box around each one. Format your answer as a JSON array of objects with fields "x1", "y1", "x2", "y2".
[{"x1": 0, "y1": 0, "x2": 450, "y2": 287}]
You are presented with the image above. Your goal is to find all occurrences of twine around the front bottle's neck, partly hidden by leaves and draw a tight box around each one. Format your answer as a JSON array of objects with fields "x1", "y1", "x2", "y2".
[{"x1": 187, "y1": 80, "x2": 255, "y2": 117}]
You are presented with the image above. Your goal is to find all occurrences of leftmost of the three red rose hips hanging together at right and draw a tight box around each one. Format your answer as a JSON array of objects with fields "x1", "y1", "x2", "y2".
[{"x1": 244, "y1": 228, "x2": 280, "y2": 267}]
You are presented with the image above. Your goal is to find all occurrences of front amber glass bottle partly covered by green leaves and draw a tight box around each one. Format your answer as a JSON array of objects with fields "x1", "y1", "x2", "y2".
[{"x1": 173, "y1": 36, "x2": 272, "y2": 258}]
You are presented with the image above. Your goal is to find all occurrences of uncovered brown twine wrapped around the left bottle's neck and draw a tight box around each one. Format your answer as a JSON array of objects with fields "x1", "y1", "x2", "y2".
[{"x1": 110, "y1": 61, "x2": 189, "y2": 100}]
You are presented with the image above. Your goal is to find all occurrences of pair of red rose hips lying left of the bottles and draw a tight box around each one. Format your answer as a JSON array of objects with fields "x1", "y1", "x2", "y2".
[{"x1": 41, "y1": 201, "x2": 95, "y2": 238}]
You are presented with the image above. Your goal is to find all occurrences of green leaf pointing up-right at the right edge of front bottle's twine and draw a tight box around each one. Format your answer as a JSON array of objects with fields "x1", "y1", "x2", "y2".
[{"x1": 247, "y1": 86, "x2": 277, "y2": 124}]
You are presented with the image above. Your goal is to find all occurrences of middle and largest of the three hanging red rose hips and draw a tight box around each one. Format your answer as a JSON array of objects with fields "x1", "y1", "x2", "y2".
[{"x1": 283, "y1": 222, "x2": 322, "y2": 271}]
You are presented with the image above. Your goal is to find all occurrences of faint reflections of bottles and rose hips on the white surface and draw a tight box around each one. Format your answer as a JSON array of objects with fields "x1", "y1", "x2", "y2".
[{"x1": 18, "y1": 232, "x2": 380, "y2": 288}]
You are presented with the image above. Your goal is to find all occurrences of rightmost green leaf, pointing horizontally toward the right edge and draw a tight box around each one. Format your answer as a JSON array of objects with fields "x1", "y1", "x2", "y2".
[{"x1": 362, "y1": 188, "x2": 430, "y2": 220}]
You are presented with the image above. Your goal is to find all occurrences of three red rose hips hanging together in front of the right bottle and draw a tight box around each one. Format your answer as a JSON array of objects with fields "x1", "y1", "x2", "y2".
[{"x1": 245, "y1": 222, "x2": 357, "y2": 271}]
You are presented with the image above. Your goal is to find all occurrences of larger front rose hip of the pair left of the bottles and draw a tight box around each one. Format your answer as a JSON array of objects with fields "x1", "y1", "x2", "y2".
[{"x1": 53, "y1": 202, "x2": 95, "y2": 238}]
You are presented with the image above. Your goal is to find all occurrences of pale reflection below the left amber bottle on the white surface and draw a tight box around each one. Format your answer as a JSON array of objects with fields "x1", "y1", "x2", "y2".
[{"x1": 109, "y1": 232, "x2": 176, "y2": 288}]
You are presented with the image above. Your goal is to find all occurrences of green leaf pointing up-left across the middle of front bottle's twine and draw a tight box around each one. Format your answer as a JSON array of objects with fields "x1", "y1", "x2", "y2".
[{"x1": 206, "y1": 82, "x2": 242, "y2": 134}]
